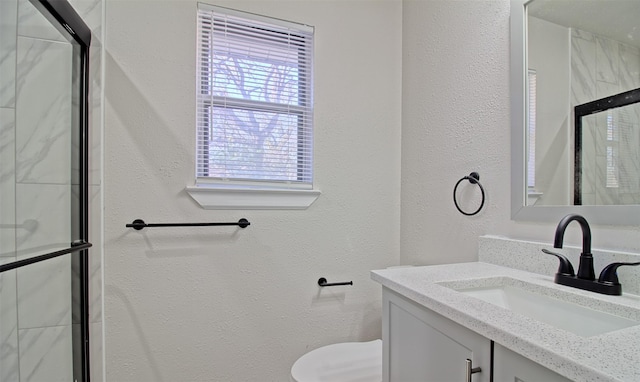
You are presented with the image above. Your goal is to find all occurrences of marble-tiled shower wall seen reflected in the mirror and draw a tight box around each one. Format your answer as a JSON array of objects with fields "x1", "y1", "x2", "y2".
[{"x1": 571, "y1": 29, "x2": 640, "y2": 204}]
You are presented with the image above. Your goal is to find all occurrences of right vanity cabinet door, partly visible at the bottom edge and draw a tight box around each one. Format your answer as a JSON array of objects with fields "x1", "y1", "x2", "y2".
[{"x1": 493, "y1": 344, "x2": 571, "y2": 382}]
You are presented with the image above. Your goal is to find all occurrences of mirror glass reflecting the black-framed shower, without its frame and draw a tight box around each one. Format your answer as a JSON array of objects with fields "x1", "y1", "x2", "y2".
[{"x1": 525, "y1": 0, "x2": 640, "y2": 206}]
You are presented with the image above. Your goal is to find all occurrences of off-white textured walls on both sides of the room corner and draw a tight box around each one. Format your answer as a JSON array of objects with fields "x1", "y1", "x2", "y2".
[{"x1": 104, "y1": 0, "x2": 640, "y2": 381}]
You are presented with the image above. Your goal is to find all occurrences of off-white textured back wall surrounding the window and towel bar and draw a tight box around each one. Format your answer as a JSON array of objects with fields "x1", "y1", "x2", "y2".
[{"x1": 104, "y1": 0, "x2": 402, "y2": 382}]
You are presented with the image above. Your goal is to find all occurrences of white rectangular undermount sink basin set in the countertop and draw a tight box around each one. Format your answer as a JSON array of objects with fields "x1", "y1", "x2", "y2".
[{"x1": 440, "y1": 277, "x2": 640, "y2": 337}]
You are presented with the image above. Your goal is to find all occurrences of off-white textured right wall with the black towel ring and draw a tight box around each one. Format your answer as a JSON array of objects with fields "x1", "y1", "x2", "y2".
[{"x1": 401, "y1": 0, "x2": 640, "y2": 264}]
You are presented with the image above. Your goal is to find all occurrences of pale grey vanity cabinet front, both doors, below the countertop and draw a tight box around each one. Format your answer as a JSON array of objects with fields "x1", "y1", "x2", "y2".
[{"x1": 382, "y1": 288, "x2": 570, "y2": 382}]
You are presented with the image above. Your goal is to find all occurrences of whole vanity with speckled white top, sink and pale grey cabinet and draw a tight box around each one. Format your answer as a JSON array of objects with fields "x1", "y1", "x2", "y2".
[{"x1": 371, "y1": 238, "x2": 640, "y2": 382}]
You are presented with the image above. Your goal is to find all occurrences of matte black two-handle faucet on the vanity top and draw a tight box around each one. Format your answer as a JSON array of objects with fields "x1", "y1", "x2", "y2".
[{"x1": 542, "y1": 214, "x2": 640, "y2": 296}]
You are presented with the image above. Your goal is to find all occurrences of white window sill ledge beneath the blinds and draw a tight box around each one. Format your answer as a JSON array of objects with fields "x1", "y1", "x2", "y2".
[{"x1": 185, "y1": 186, "x2": 320, "y2": 210}]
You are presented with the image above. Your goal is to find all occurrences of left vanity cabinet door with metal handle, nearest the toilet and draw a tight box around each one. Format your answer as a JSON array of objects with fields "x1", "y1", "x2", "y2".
[{"x1": 382, "y1": 288, "x2": 491, "y2": 382}]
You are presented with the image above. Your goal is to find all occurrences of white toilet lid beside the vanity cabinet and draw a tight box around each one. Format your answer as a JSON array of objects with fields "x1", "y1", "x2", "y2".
[{"x1": 291, "y1": 340, "x2": 382, "y2": 382}]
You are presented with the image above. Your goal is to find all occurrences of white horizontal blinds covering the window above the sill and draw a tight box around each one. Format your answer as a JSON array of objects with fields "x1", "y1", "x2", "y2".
[{"x1": 196, "y1": 4, "x2": 313, "y2": 187}]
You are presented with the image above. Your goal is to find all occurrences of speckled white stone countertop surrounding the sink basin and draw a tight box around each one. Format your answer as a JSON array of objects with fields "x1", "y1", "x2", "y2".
[{"x1": 371, "y1": 262, "x2": 640, "y2": 382}]
